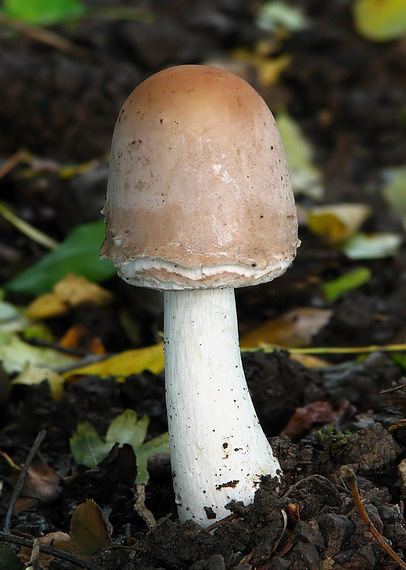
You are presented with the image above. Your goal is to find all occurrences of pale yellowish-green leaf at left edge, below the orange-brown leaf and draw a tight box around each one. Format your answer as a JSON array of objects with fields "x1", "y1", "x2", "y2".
[{"x1": 0, "y1": 333, "x2": 77, "y2": 374}]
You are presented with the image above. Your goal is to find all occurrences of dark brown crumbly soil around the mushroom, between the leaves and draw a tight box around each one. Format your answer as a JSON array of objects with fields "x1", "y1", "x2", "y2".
[{"x1": 0, "y1": 0, "x2": 406, "y2": 570}]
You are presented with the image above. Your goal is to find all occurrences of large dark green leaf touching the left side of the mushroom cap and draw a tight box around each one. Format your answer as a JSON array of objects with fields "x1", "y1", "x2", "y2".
[{"x1": 6, "y1": 221, "x2": 115, "y2": 295}]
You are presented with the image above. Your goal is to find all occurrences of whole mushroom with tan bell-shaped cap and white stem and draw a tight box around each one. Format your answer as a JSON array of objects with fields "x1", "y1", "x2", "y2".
[{"x1": 102, "y1": 65, "x2": 299, "y2": 527}]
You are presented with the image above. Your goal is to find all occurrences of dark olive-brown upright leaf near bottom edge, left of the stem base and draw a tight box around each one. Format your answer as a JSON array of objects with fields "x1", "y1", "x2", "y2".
[{"x1": 53, "y1": 499, "x2": 112, "y2": 560}]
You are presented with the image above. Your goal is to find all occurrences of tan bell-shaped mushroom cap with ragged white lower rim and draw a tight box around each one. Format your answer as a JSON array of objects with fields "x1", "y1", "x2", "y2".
[{"x1": 101, "y1": 65, "x2": 300, "y2": 290}]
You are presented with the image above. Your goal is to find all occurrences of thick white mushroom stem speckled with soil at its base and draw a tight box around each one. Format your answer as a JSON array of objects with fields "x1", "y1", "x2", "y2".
[{"x1": 165, "y1": 288, "x2": 280, "y2": 526}]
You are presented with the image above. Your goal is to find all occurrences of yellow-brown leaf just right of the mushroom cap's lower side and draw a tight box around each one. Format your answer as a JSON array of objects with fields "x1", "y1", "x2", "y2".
[{"x1": 307, "y1": 203, "x2": 371, "y2": 245}]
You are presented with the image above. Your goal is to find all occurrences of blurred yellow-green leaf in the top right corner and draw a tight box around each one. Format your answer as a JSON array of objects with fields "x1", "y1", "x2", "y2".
[{"x1": 353, "y1": 0, "x2": 406, "y2": 42}]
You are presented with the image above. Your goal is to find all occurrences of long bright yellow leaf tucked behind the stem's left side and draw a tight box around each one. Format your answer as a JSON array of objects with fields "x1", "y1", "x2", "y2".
[{"x1": 64, "y1": 343, "x2": 164, "y2": 378}]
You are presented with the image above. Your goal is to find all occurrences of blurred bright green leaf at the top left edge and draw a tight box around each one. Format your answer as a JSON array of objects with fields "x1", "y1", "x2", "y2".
[{"x1": 3, "y1": 0, "x2": 86, "y2": 26}]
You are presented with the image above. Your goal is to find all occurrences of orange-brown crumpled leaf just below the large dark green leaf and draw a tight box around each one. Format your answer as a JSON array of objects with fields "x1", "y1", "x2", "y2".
[{"x1": 27, "y1": 273, "x2": 113, "y2": 319}]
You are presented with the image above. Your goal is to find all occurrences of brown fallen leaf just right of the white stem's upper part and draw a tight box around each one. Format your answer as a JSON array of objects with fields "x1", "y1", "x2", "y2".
[{"x1": 240, "y1": 307, "x2": 331, "y2": 348}]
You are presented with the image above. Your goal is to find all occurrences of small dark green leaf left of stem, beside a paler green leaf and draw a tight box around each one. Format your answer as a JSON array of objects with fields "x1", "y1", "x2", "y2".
[{"x1": 70, "y1": 422, "x2": 113, "y2": 468}]
